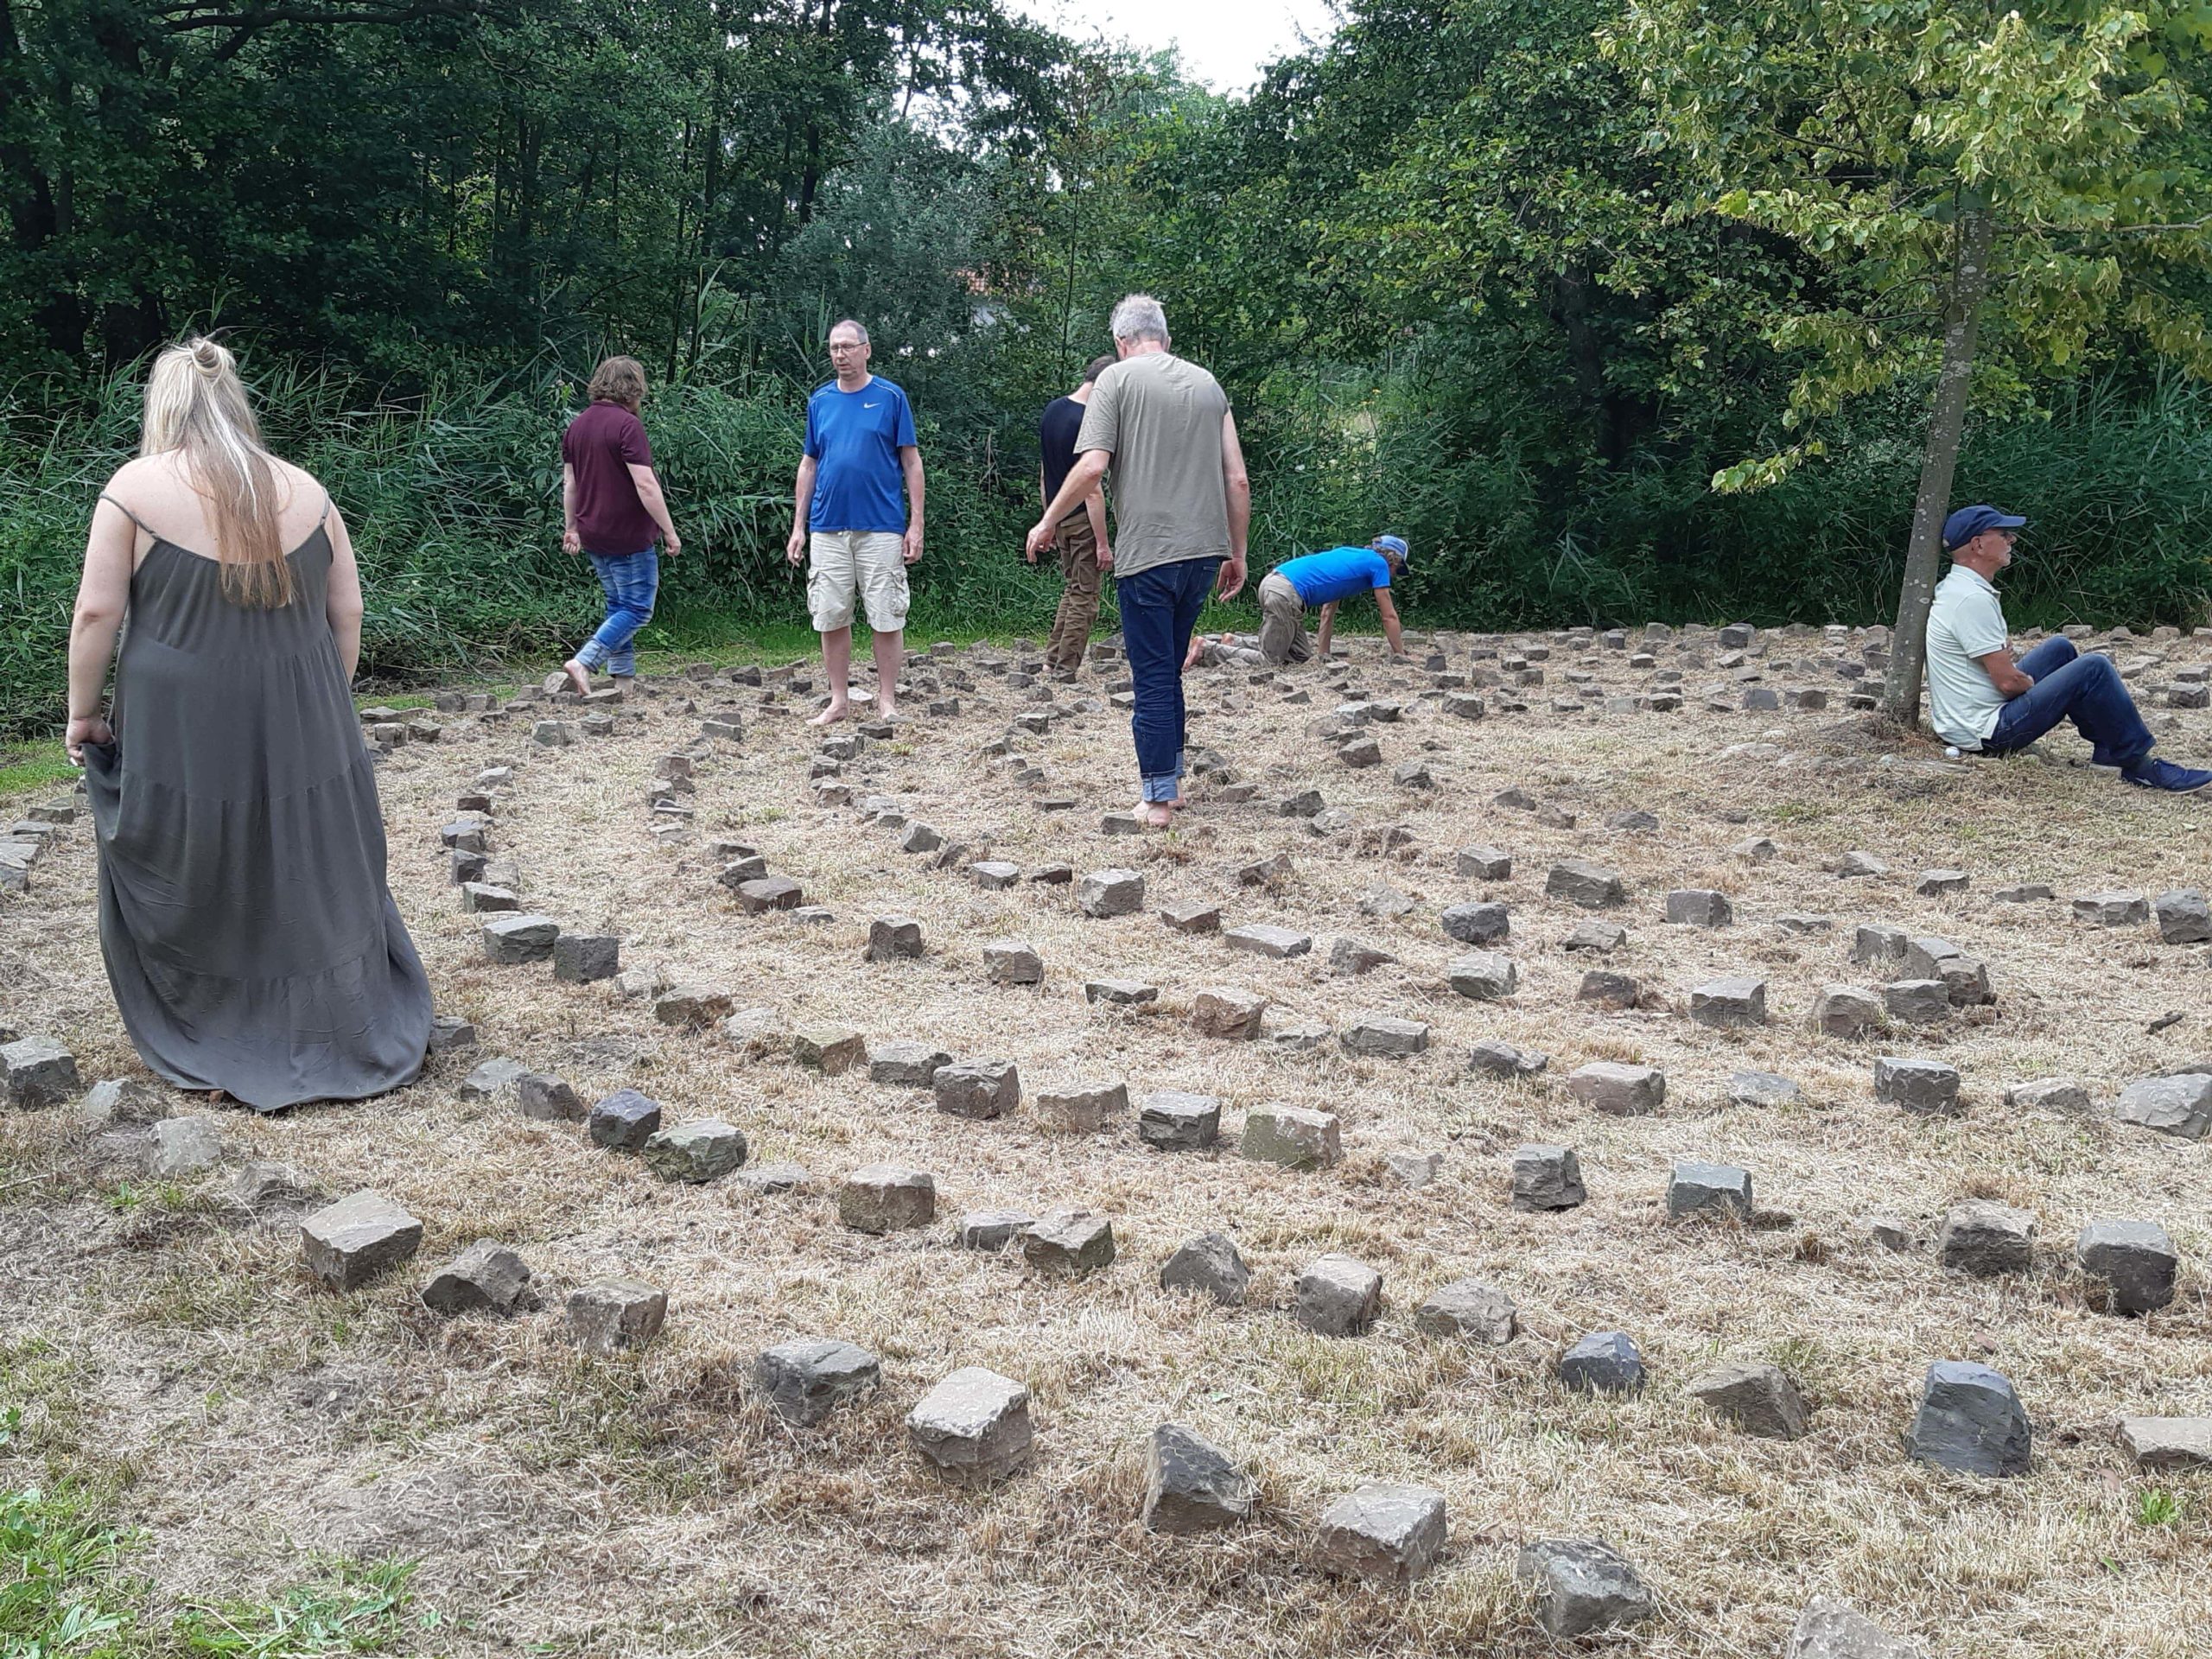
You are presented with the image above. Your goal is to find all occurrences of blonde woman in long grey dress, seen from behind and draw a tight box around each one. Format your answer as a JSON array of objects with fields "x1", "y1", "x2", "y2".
[{"x1": 67, "y1": 340, "x2": 431, "y2": 1110}]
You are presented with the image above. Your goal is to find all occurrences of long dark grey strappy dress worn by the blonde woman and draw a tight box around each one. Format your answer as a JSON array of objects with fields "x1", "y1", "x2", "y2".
[{"x1": 84, "y1": 506, "x2": 431, "y2": 1113}]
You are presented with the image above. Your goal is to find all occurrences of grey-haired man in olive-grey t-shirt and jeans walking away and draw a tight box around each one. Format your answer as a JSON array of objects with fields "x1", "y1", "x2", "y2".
[{"x1": 1028, "y1": 294, "x2": 1252, "y2": 830}]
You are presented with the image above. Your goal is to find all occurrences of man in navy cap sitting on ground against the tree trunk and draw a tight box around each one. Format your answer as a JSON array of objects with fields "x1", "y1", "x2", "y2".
[{"x1": 1927, "y1": 506, "x2": 2212, "y2": 794}]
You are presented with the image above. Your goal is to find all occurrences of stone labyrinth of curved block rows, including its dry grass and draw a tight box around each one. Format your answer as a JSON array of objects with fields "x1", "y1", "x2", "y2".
[{"x1": 0, "y1": 624, "x2": 2212, "y2": 1659}]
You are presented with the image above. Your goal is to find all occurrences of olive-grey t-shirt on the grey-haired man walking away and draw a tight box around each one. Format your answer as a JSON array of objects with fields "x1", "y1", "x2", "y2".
[{"x1": 1075, "y1": 352, "x2": 1230, "y2": 577}]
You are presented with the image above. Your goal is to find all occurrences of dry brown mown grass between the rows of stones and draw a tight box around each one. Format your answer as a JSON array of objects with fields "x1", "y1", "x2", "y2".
[{"x1": 0, "y1": 641, "x2": 2212, "y2": 1659}]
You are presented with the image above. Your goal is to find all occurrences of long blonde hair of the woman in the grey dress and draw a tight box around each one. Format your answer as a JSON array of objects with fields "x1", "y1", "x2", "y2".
[{"x1": 139, "y1": 336, "x2": 292, "y2": 611}]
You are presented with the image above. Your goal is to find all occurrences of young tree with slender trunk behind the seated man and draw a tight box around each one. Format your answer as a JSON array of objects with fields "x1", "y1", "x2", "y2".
[{"x1": 1601, "y1": 0, "x2": 2212, "y2": 726}]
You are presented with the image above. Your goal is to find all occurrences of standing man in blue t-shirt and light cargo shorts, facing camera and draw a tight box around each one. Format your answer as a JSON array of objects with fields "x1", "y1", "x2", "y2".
[{"x1": 783, "y1": 316, "x2": 923, "y2": 726}]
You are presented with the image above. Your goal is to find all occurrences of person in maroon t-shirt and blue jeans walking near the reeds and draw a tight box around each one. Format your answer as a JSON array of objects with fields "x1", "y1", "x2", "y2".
[{"x1": 546, "y1": 356, "x2": 683, "y2": 692}]
